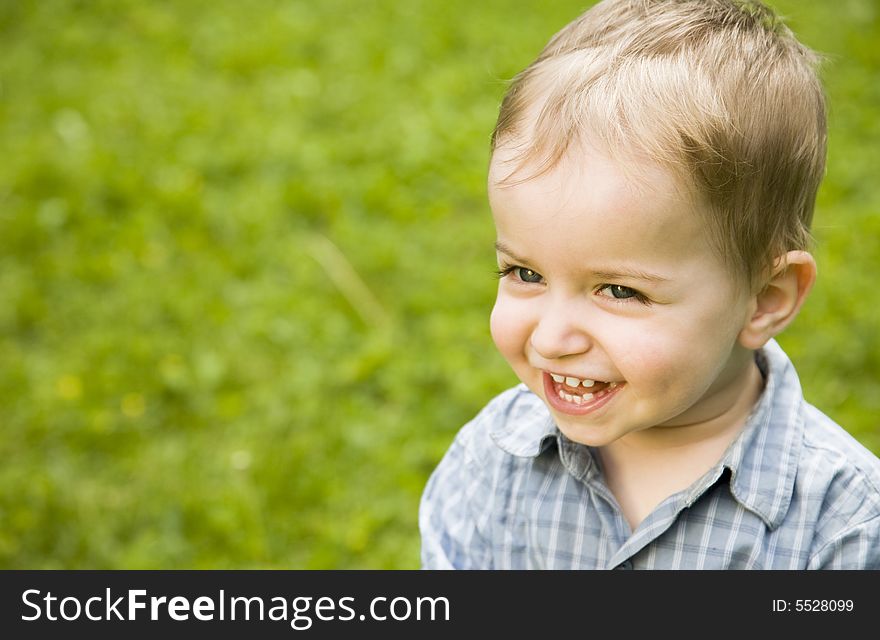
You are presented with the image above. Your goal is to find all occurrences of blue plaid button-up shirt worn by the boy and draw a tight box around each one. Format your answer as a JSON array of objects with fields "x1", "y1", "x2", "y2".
[{"x1": 419, "y1": 341, "x2": 880, "y2": 569}]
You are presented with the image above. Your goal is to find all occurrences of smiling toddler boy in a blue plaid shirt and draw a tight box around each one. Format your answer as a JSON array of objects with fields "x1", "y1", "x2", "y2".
[{"x1": 420, "y1": 0, "x2": 880, "y2": 569}]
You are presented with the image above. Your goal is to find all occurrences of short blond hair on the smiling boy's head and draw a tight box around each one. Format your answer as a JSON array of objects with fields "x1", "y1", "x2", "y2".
[{"x1": 492, "y1": 0, "x2": 826, "y2": 288}]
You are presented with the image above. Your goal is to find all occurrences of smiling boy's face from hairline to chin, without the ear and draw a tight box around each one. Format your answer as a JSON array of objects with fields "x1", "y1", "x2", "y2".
[{"x1": 489, "y1": 145, "x2": 754, "y2": 446}]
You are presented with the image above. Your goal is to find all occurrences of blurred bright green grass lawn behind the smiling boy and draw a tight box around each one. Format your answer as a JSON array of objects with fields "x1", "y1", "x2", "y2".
[{"x1": 0, "y1": 0, "x2": 880, "y2": 569}]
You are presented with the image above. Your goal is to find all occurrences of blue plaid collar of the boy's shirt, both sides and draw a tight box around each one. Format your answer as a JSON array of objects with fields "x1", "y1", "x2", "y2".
[{"x1": 490, "y1": 340, "x2": 804, "y2": 529}]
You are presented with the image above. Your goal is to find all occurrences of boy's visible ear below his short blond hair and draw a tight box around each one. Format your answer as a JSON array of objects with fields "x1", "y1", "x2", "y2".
[{"x1": 739, "y1": 251, "x2": 816, "y2": 349}]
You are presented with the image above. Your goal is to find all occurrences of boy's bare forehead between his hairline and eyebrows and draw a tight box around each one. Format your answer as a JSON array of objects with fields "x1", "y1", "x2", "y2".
[{"x1": 488, "y1": 144, "x2": 720, "y2": 275}]
